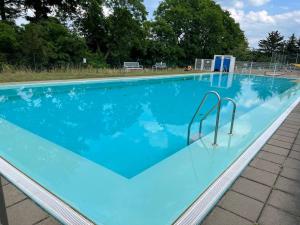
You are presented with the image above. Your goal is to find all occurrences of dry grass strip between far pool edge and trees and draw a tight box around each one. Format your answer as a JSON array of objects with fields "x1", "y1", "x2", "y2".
[{"x1": 0, "y1": 68, "x2": 204, "y2": 83}]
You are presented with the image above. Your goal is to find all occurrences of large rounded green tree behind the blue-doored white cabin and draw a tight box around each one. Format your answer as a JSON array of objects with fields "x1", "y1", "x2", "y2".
[{"x1": 153, "y1": 0, "x2": 247, "y2": 64}]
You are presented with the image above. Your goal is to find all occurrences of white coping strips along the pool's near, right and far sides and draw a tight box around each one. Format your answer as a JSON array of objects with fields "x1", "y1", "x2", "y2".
[{"x1": 0, "y1": 73, "x2": 300, "y2": 225}]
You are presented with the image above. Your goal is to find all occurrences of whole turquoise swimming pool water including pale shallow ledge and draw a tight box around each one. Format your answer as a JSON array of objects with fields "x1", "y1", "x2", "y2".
[{"x1": 0, "y1": 74, "x2": 300, "y2": 225}]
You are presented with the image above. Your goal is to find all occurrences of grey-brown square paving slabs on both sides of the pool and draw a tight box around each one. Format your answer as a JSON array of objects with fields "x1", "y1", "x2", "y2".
[{"x1": 0, "y1": 104, "x2": 300, "y2": 225}]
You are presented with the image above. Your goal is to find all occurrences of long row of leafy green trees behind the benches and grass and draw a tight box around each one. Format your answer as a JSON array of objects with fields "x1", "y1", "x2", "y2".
[{"x1": 0, "y1": 0, "x2": 248, "y2": 69}]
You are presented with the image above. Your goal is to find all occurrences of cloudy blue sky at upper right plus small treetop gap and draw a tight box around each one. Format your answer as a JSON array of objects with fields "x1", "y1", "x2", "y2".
[{"x1": 144, "y1": 0, "x2": 300, "y2": 48}]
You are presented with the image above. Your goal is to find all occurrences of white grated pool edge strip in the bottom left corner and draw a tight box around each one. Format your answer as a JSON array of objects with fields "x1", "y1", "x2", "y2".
[{"x1": 0, "y1": 157, "x2": 94, "y2": 225}]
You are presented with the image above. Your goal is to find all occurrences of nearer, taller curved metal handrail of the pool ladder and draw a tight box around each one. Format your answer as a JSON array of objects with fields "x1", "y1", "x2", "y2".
[{"x1": 187, "y1": 91, "x2": 221, "y2": 145}]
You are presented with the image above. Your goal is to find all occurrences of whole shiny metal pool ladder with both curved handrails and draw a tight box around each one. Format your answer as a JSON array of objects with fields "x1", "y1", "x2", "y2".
[{"x1": 187, "y1": 91, "x2": 236, "y2": 145}]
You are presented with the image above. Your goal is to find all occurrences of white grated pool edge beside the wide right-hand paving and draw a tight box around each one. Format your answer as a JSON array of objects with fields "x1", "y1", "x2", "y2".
[{"x1": 173, "y1": 97, "x2": 300, "y2": 225}]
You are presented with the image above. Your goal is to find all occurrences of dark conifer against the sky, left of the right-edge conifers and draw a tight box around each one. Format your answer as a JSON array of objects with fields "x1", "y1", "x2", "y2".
[{"x1": 258, "y1": 31, "x2": 284, "y2": 56}]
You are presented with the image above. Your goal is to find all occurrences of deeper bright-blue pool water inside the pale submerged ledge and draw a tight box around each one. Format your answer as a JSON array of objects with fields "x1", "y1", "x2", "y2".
[{"x1": 0, "y1": 74, "x2": 296, "y2": 178}]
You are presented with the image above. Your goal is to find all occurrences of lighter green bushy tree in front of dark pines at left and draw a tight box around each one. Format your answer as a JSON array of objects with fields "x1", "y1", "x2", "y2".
[{"x1": 21, "y1": 18, "x2": 87, "y2": 69}]
